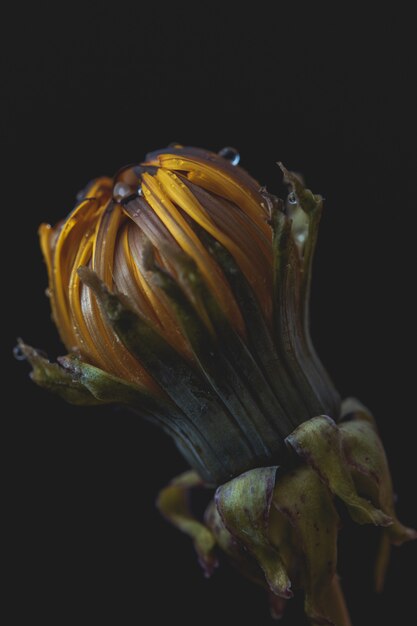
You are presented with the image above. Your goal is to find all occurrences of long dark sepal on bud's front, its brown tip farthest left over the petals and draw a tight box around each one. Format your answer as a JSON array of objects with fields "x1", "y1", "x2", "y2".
[{"x1": 78, "y1": 267, "x2": 254, "y2": 484}]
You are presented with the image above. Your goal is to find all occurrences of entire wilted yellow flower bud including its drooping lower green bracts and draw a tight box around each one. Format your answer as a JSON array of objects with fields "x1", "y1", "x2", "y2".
[{"x1": 20, "y1": 145, "x2": 415, "y2": 624}]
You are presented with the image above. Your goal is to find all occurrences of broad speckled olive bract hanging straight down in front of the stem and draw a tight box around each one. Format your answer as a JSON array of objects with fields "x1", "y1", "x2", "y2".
[{"x1": 273, "y1": 466, "x2": 339, "y2": 624}]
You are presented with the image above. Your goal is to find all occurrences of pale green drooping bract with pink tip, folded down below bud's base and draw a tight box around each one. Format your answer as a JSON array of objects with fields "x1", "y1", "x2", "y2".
[{"x1": 215, "y1": 467, "x2": 292, "y2": 598}]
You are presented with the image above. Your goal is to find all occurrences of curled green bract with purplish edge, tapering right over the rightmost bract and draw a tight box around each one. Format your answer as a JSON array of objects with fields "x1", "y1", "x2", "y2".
[{"x1": 286, "y1": 415, "x2": 392, "y2": 526}]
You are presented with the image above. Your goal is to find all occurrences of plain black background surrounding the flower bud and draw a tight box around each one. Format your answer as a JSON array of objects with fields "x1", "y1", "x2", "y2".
[{"x1": 1, "y1": 2, "x2": 417, "y2": 626}]
